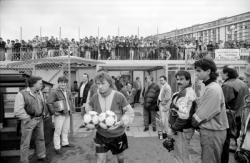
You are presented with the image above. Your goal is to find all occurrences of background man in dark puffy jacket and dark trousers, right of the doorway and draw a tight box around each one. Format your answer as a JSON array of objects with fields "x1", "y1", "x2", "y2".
[{"x1": 143, "y1": 76, "x2": 160, "y2": 131}]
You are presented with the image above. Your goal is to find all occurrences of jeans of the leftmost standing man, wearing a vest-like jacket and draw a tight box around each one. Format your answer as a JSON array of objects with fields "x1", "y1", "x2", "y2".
[{"x1": 20, "y1": 117, "x2": 46, "y2": 163}]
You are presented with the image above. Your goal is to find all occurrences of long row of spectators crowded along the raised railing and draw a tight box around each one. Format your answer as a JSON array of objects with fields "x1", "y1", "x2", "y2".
[{"x1": 0, "y1": 35, "x2": 250, "y2": 61}]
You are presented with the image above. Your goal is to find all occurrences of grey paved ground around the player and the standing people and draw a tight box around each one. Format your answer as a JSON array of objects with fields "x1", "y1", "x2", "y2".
[{"x1": 2, "y1": 105, "x2": 235, "y2": 163}]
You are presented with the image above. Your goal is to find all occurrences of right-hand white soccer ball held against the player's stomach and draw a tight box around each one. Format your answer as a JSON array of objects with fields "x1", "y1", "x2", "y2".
[{"x1": 99, "y1": 110, "x2": 117, "y2": 129}]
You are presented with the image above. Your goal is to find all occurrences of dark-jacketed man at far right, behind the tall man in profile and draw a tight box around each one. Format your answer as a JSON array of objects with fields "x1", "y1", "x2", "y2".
[{"x1": 221, "y1": 66, "x2": 249, "y2": 163}]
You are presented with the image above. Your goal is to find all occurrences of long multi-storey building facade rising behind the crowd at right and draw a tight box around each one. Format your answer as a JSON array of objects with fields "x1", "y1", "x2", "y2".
[{"x1": 156, "y1": 12, "x2": 250, "y2": 43}]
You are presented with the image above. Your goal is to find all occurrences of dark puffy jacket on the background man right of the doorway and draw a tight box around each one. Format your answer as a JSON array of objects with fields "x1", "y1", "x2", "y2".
[{"x1": 143, "y1": 83, "x2": 160, "y2": 111}]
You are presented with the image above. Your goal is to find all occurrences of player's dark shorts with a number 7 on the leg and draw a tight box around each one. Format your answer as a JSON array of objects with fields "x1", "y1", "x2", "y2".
[{"x1": 94, "y1": 133, "x2": 128, "y2": 155}]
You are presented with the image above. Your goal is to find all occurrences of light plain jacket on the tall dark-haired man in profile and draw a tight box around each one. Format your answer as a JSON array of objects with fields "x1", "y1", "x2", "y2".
[{"x1": 192, "y1": 81, "x2": 229, "y2": 131}]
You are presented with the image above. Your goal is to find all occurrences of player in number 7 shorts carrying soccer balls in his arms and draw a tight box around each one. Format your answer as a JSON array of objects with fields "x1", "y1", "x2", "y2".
[{"x1": 87, "y1": 72, "x2": 134, "y2": 163}]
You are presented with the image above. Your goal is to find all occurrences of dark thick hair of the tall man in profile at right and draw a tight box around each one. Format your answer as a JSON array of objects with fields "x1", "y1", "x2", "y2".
[{"x1": 194, "y1": 58, "x2": 219, "y2": 80}]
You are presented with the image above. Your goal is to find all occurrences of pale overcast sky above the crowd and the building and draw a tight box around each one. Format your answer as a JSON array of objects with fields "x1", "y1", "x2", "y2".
[{"x1": 0, "y1": 0, "x2": 250, "y2": 40}]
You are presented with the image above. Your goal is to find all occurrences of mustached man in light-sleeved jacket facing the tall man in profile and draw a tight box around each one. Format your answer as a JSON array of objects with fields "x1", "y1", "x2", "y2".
[{"x1": 165, "y1": 71, "x2": 196, "y2": 163}]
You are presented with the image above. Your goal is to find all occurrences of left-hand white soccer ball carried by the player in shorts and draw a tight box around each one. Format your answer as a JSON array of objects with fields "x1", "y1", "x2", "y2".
[{"x1": 83, "y1": 111, "x2": 99, "y2": 129}]
